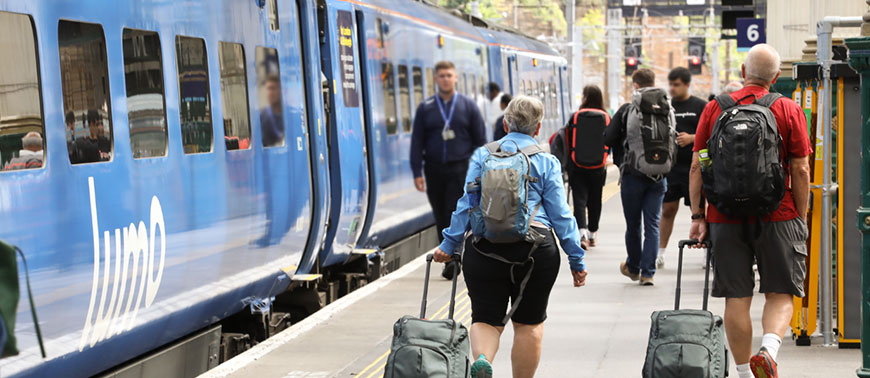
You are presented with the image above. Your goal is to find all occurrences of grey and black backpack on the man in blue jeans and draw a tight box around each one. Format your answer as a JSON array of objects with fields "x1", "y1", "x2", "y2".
[{"x1": 623, "y1": 88, "x2": 677, "y2": 177}]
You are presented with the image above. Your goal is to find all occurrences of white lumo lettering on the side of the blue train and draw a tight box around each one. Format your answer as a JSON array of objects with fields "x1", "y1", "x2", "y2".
[{"x1": 79, "y1": 177, "x2": 166, "y2": 351}]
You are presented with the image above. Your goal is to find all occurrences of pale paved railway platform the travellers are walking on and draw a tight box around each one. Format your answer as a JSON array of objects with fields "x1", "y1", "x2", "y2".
[{"x1": 204, "y1": 171, "x2": 861, "y2": 378}]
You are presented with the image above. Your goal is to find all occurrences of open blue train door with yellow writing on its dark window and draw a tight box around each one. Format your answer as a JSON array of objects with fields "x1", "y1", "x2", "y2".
[{"x1": 318, "y1": 2, "x2": 370, "y2": 266}]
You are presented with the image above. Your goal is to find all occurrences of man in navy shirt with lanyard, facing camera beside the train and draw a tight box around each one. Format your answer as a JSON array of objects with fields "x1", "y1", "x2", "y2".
[{"x1": 410, "y1": 61, "x2": 486, "y2": 279}]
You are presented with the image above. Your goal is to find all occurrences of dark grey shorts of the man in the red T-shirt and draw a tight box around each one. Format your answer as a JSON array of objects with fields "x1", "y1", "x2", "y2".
[{"x1": 710, "y1": 218, "x2": 809, "y2": 298}]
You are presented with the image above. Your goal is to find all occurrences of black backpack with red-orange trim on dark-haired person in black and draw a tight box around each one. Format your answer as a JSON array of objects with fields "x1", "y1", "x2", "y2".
[{"x1": 564, "y1": 109, "x2": 607, "y2": 169}]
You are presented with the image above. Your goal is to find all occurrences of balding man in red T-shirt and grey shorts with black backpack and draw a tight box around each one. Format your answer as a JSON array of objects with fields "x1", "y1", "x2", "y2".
[{"x1": 689, "y1": 44, "x2": 812, "y2": 378}]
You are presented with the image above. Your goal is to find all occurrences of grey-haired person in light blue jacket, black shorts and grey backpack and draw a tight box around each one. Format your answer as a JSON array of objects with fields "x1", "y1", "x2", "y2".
[{"x1": 435, "y1": 96, "x2": 587, "y2": 378}]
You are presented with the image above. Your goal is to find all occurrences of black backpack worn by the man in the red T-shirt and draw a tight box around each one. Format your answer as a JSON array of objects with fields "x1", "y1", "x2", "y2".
[{"x1": 702, "y1": 93, "x2": 785, "y2": 219}]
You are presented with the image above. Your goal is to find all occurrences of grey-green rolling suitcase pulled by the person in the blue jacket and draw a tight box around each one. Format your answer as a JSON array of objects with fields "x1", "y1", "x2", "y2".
[{"x1": 384, "y1": 254, "x2": 470, "y2": 378}]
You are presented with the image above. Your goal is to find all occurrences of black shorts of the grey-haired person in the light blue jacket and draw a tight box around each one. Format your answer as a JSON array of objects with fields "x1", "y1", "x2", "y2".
[{"x1": 462, "y1": 230, "x2": 562, "y2": 327}]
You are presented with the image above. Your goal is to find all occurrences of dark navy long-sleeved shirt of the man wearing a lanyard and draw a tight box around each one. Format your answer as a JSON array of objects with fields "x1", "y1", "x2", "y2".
[{"x1": 411, "y1": 92, "x2": 486, "y2": 177}]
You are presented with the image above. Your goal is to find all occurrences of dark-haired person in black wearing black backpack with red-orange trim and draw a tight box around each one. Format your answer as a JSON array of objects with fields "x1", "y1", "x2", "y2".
[{"x1": 551, "y1": 85, "x2": 610, "y2": 248}]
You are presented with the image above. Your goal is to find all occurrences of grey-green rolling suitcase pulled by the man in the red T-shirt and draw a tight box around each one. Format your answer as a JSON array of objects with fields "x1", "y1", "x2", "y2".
[{"x1": 643, "y1": 240, "x2": 728, "y2": 378}]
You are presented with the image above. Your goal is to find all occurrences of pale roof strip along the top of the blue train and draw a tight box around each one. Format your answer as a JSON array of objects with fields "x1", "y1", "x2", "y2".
[{"x1": 343, "y1": 0, "x2": 561, "y2": 58}]
